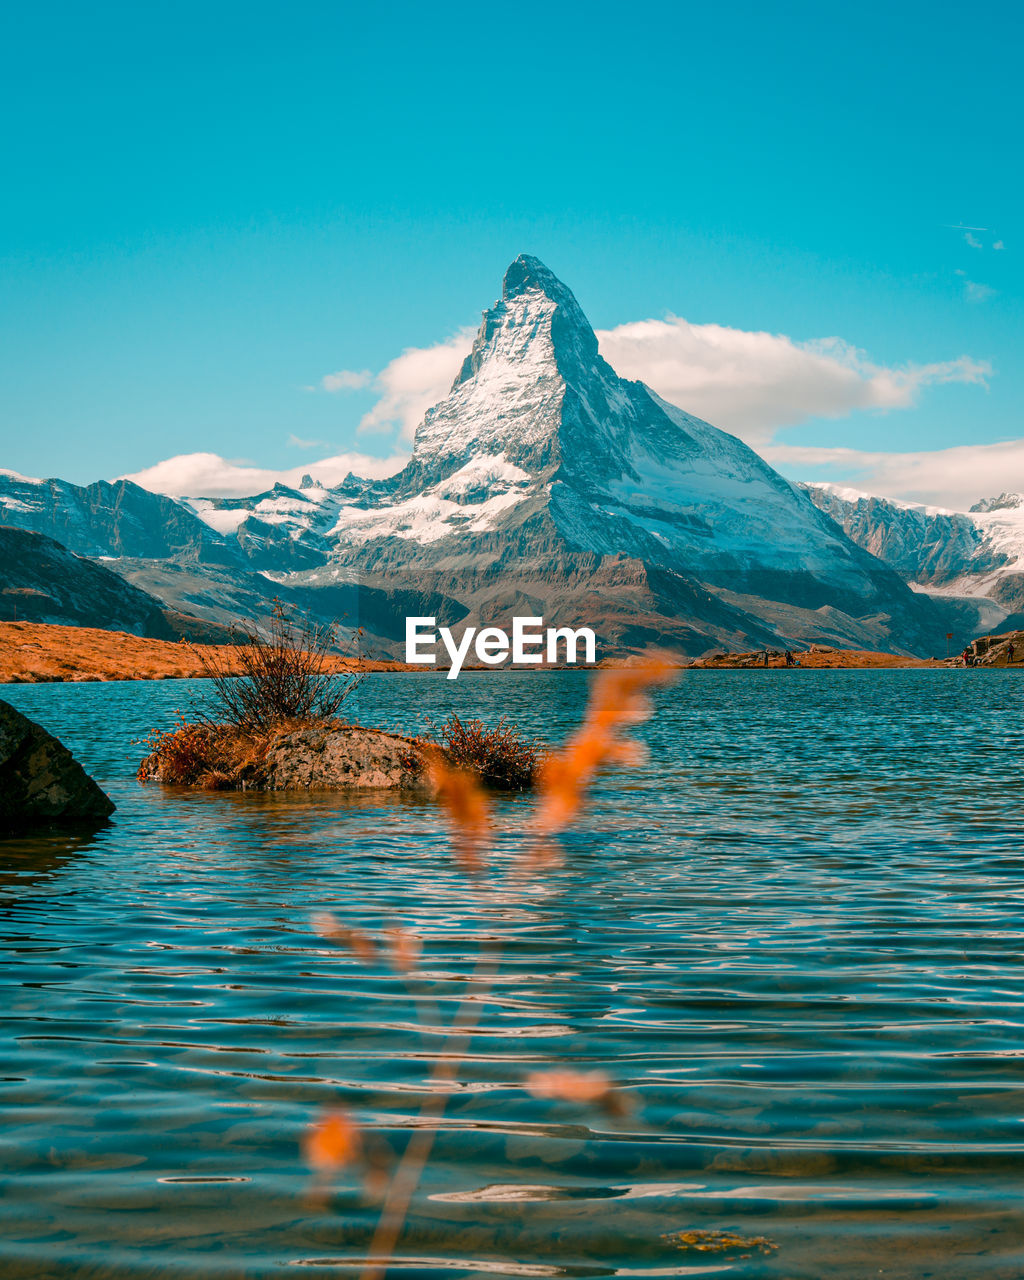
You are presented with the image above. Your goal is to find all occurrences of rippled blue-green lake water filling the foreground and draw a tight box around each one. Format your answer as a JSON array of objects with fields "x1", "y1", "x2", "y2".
[{"x1": 0, "y1": 671, "x2": 1024, "y2": 1280}]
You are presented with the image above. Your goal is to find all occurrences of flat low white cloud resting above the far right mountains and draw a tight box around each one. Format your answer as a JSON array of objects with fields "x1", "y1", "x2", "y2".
[{"x1": 762, "y1": 439, "x2": 1024, "y2": 511}]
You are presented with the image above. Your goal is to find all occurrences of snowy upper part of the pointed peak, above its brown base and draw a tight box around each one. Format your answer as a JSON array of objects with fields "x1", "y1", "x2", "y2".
[{"x1": 312, "y1": 256, "x2": 885, "y2": 586}]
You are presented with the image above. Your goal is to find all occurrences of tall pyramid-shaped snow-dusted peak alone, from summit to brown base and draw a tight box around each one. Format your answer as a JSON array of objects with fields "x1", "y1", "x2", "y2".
[{"x1": 235, "y1": 256, "x2": 940, "y2": 653}]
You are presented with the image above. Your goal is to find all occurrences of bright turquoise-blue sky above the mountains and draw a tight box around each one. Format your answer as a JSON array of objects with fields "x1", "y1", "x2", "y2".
[{"x1": 0, "y1": 0, "x2": 1024, "y2": 500}]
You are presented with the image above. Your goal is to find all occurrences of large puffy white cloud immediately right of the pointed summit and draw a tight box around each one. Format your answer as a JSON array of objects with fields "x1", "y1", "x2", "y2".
[{"x1": 598, "y1": 316, "x2": 992, "y2": 444}]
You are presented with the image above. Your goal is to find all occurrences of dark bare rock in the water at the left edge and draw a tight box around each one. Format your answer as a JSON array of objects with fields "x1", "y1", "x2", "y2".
[{"x1": 0, "y1": 701, "x2": 114, "y2": 833}]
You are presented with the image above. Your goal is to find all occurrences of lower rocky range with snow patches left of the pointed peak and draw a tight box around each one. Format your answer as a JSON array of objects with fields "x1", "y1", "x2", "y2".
[{"x1": 0, "y1": 470, "x2": 466, "y2": 652}]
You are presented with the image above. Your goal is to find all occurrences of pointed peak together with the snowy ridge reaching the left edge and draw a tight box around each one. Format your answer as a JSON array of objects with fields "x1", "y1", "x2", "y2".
[{"x1": 0, "y1": 256, "x2": 962, "y2": 655}]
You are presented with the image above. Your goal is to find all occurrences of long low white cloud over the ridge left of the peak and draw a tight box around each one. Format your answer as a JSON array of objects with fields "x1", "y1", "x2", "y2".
[{"x1": 116, "y1": 453, "x2": 408, "y2": 498}]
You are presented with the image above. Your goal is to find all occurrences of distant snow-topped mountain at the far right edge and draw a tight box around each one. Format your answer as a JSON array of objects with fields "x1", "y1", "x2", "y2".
[{"x1": 800, "y1": 484, "x2": 1024, "y2": 626}]
